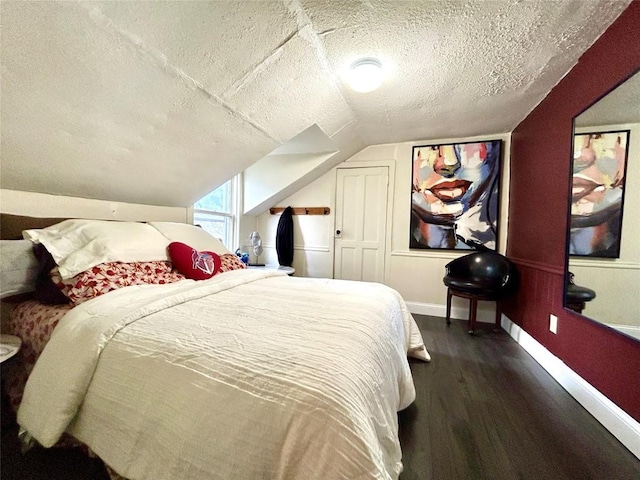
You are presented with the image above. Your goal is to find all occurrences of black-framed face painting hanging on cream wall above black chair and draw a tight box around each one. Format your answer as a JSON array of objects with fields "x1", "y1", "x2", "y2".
[{"x1": 409, "y1": 140, "x2": 502, "y2": 250}]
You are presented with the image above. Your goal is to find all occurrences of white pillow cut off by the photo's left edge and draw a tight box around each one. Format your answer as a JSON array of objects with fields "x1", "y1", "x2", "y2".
[{"x1": 0, "y1": 240, "x2": 38, "y2": 298}]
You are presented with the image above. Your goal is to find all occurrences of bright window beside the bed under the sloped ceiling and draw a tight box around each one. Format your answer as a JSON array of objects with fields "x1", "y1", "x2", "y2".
[{"x1": 193, "y1": 179, "x2": 236, "y2": 251}]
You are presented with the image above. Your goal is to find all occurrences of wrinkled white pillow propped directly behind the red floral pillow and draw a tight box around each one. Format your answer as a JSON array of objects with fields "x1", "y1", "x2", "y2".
[{"x1": 22, "y1": 219, "x2": 169, "y2": 279}]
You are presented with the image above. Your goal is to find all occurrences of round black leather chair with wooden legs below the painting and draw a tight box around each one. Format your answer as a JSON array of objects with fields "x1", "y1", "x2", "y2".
[{"x1": 443, "y1": 251, "x2": 518, "y2": 334}]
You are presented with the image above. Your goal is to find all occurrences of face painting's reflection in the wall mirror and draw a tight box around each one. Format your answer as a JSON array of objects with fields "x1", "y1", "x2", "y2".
[{"x1": 569, "y1": 130, "x2": 629, "y2": 258}]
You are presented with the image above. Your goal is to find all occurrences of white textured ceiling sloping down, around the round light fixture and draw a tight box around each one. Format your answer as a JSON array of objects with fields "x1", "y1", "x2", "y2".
[{"x1": 0, "y1": 0, "x2": 629, "y2": 206}]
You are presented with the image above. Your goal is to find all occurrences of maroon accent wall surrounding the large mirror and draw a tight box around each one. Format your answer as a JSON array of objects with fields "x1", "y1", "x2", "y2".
[{"x1": 504, "y1": 0, "x2": 640, "y2": 421}]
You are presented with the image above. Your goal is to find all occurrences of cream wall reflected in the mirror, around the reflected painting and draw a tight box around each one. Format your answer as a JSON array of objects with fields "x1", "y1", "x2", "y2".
[{"x1": 569, "y1": 123, "x2": 640, "y2": 333}]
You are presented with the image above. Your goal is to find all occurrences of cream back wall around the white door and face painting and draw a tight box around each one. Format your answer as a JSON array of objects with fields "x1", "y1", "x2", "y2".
[{"x1": 258, "y1": 134, "x2": 510, "y2": 321}]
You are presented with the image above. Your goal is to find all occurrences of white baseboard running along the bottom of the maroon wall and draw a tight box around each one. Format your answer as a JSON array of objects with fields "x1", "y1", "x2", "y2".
[{"x1": 502, "y1": 312, "x2": 640, "y2": 459}]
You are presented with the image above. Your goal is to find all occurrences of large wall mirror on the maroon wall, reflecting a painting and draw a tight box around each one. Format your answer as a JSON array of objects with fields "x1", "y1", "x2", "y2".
[{"x1": 564, "y1": 71, "x2": 640, "y2": 341}]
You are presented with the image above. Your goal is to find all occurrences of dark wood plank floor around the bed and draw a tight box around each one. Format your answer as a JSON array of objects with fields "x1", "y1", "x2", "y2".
[{"x1": 0, "y1": 315, "x2": 640, "y2": 480}]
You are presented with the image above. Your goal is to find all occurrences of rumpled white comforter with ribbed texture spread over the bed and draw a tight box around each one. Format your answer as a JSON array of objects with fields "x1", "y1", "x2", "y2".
[{"x1": 18, "y1": 270, "x2": 429, "y2": 480}]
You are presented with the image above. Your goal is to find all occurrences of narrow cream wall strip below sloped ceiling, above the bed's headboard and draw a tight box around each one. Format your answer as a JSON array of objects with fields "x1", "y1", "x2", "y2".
[{"x1": 0, "y1": 189, "x2": 189, "y2": 223}]
